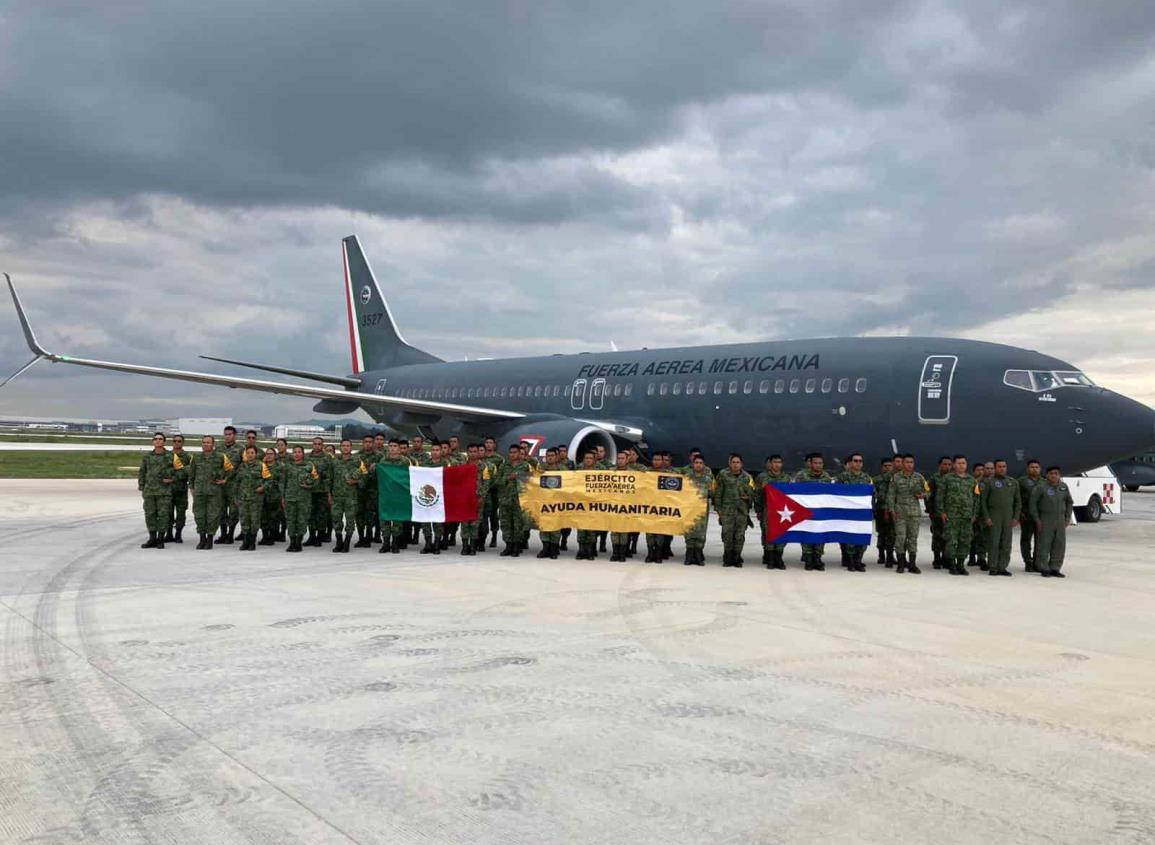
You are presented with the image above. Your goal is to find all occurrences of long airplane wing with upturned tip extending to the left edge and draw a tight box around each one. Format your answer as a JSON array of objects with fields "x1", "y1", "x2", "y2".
[{"x1": 5, "y1": 274, "x2": 526, "y2": 421}]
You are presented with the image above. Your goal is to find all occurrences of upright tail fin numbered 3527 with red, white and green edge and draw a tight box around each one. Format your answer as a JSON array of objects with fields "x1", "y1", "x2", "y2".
[{"x1": 341, "y1": 234, "x2": 441, "y2": 373}]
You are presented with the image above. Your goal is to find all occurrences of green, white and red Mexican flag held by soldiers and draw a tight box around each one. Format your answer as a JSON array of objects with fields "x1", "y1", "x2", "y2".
[{"x1": 377, "y1": 464, "x2": 478, "y2": 522}]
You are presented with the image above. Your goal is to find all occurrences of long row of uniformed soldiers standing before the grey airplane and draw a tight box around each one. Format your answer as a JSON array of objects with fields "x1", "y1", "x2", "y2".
[{"x1": 137, "y1": 426, "x2": 1073, "y2": 578}]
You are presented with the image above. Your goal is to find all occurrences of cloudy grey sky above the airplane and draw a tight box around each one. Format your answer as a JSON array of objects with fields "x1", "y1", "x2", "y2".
[{"x1": 0, "y1": 0, "x2": 1155, "y2": 421}]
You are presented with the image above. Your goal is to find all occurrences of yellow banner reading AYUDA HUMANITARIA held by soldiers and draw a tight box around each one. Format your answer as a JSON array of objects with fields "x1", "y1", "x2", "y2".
[{"x1": 521, "y1": 470, "x2": 706, "y2": 534}]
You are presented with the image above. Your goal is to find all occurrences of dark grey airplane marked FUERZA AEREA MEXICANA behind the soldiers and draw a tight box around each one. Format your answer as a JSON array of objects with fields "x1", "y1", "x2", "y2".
[{"x1": 5, "y1": 235, "x2": 1155, "y2": 473}]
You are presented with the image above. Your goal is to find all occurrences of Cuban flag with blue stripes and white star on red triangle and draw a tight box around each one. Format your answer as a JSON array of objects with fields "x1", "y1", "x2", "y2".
[{"x1": 766, "y1": 481, "x2": 874, "y2": 546}]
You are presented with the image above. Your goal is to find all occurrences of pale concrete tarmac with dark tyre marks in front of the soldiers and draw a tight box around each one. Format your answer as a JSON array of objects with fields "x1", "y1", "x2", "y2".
[{"x1": 0, "y1": 480, "x2": 1155, "y2": 845}]
